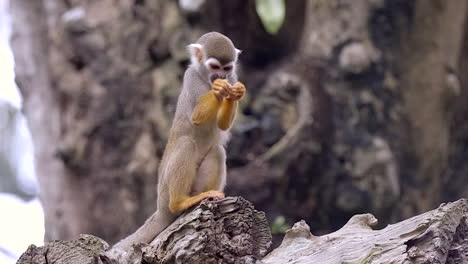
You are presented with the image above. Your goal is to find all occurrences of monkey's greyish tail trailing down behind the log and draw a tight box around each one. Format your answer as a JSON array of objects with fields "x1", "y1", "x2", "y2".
[{"x1": 112, "y1": 210, "x2": 174, "y2": 251}]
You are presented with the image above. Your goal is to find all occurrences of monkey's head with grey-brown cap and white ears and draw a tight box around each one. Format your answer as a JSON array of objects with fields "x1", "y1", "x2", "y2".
[{"x1": 188, "y1": 32, "x2": 241, "y2": 83}]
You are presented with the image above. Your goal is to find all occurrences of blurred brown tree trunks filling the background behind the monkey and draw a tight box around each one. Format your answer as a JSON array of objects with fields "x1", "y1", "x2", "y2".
[{"x1": 11, "y1": 0, "x2": 468, "y2": 242}]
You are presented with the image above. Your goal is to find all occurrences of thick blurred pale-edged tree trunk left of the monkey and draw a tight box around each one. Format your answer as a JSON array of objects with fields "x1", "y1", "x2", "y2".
[{"x1": 11, "y1": 0, "x2": 168, "y2": 242}]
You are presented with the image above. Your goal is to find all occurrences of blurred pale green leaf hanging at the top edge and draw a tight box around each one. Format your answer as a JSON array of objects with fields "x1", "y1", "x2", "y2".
[{"x1": 255, "y1": 0, "x2": 286, "y2": 34}]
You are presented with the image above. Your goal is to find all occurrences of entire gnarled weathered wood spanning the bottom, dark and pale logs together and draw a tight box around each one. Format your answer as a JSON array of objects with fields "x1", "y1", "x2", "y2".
[{"x1": 18, "y1": 198, "x2": 468, "y2": 264}]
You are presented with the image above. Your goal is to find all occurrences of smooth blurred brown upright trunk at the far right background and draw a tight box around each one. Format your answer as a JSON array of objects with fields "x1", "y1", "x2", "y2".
[{"x1": 397, "y1": 0, "x2": 468, "y2": 219}]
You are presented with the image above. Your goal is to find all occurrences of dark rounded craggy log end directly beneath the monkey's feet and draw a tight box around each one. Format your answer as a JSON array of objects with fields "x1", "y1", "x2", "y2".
[{"x1": 145, "y1": 197, "x2": 271, "y2": 263}]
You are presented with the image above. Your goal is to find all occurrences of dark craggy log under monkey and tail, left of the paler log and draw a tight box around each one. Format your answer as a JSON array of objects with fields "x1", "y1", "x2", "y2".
[{"x1": 18, "y1": 197, "x2": 271, "y2": 264}]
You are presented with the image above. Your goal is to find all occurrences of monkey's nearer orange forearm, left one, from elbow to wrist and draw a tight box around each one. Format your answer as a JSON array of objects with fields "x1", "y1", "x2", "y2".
[{"x1": 192, "y1": 91, "x2": 221, "y2": 125}]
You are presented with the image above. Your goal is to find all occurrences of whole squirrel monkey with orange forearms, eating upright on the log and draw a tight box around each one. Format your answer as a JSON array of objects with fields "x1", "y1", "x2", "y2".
[{"x1": 114, "y1": 32, "x2": 245, "y2": 250}]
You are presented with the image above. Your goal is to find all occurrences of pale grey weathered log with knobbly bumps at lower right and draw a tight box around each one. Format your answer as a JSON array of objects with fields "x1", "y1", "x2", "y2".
[{"x1": 263, "y1": 199, "x2": 468, "y2": 264}]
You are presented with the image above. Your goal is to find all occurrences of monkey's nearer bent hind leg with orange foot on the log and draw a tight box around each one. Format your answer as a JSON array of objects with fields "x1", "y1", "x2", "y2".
[{"x1": 168, "y1": 137, "x2": 224, "y2": 212}]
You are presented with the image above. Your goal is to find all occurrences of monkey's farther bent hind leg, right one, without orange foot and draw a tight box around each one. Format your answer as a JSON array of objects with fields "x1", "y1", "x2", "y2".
[{"x1": 192, "y1": 145, "x2": 226, "y2": 193}]
